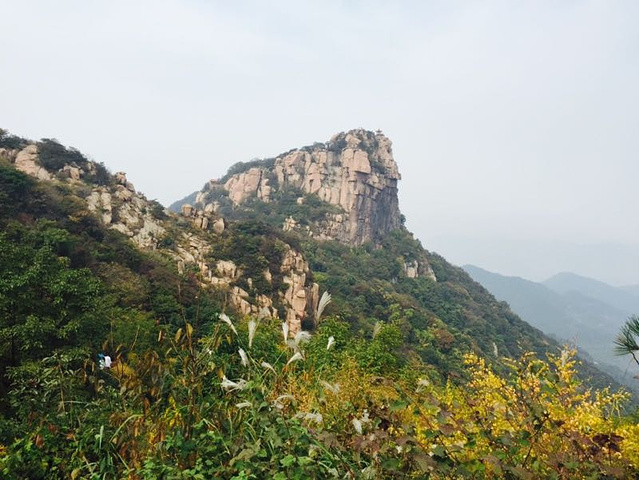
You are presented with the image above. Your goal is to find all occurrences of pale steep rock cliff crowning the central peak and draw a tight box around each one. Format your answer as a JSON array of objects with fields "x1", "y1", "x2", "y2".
[{"x1": 196, "y1": 130, "x2": 401, "y2": 245}]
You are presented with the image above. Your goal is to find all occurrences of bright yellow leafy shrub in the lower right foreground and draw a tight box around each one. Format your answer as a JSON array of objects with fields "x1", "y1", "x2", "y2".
[{"x1": 404, "y1": 351, "x2": 639, "y2": 478}]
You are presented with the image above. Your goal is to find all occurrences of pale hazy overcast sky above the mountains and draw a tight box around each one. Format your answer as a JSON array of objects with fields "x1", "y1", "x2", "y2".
[{"x1": 0, "y1": 0, "x2": 639, "y2": 285}]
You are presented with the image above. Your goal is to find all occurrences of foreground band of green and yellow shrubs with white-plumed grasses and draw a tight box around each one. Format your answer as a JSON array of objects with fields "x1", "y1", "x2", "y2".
[{"x1": 0, "y1": 315, "x2": 639, "y2": 479}]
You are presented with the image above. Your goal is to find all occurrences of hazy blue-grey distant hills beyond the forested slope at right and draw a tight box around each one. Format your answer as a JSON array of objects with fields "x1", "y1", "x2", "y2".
[{"x1": 463, "y1": 265, "x2": 639, "y2": 388}]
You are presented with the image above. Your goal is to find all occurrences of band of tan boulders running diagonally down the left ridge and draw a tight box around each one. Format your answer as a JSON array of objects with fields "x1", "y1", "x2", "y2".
[{"x1": 0, "y1": 138, "x2": 319, "y2": 335}]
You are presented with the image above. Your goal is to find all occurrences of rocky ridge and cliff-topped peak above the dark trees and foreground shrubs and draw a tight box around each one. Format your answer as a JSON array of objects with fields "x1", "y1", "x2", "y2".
[{"x1": 0, "y1": 130, "x2": 624, "y2": 390}]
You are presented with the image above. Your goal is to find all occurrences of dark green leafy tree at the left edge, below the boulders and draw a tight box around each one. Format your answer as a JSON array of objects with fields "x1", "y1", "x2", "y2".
[{"x1": 0, "y1": 235, "x2": 108, "y2": 365}]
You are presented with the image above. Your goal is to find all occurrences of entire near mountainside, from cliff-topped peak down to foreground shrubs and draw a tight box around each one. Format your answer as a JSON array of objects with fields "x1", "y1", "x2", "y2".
[{"x1": 0, "y1": 131, "x2": 639, "y2": 479}]
